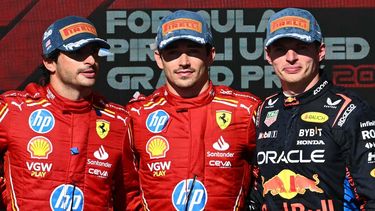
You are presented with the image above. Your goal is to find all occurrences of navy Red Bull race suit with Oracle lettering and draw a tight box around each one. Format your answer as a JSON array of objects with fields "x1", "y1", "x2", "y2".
[{"x1": 251, "y1": 77, "x2": 375, "y2": 211}]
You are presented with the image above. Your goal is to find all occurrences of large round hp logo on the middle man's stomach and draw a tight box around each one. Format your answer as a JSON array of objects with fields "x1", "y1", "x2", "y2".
[{"x1": 172, "y1": 179, "x2": 208, "y2": 211}]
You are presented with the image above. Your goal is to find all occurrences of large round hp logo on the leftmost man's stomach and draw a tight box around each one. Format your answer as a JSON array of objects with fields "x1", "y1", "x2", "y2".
[{"x1": 49, "y1": 184, "x2": 84, "y2": 211}]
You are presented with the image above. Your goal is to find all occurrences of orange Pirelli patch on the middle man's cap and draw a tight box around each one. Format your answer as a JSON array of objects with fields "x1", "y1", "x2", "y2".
[{"x1": 162, "y1": 18, "x2": 202, "y2": 36}]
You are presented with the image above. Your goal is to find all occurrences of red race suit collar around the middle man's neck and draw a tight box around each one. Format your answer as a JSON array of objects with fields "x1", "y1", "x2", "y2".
[{"x1": 163, "y1": 81, "x2": 215, "y2": 110}]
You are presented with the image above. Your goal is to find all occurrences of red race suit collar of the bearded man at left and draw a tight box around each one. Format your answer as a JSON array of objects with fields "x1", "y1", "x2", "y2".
[{"x1": 43, "y1": 85, "x2": 93, "y2": 113}]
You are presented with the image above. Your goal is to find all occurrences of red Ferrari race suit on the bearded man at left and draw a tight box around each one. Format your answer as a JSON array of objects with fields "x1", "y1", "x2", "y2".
[{"x1": 0, "y1": 84, "x2": 141, "y2": 211}]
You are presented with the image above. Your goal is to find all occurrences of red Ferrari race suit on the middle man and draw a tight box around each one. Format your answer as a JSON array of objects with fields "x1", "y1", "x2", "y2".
[{"x1": 127, "y1": 84, "x2": 260, "y2": 211}]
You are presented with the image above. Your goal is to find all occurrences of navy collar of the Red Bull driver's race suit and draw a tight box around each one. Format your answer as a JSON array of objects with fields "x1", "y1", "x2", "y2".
[{"x1": 282, "y1": 75, "x2": 332, "y2": 107}]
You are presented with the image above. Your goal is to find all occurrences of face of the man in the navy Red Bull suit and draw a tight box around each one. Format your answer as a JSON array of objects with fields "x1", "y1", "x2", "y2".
[{"x1": 266, "y1": 38, "x2": 325, "y2": 92}]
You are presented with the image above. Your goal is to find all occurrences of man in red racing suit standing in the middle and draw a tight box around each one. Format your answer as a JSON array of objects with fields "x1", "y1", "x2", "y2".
[{"x1": 127, "y1": 10, "x2": 260, "y2": 211}]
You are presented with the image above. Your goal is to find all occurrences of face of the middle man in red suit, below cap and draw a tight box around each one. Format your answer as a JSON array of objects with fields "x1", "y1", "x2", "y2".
[{"x1": 155, "y1": 40, "x2": 215, "y2": 97}]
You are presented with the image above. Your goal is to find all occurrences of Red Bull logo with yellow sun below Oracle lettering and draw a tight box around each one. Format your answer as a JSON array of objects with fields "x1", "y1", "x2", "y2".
[{"x1": 262, "y1": 169, "x2": 324, "y2": 199}]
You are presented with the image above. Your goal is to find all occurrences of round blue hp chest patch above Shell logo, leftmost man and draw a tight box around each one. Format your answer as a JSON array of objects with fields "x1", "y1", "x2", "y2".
[{"x1": 29, "y1": 109, "x2": 55, "y2": 133}]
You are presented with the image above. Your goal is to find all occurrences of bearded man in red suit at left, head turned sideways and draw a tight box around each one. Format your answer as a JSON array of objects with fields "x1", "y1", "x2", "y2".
[{"x1": 0, "y1": 16, "x2": 141, "y2": 211}]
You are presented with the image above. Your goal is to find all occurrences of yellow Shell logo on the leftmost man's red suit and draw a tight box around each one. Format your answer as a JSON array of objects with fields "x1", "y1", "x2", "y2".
[{"x1": 27, "y1": 136, "x2": 52, "y2": 159}]
